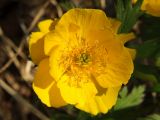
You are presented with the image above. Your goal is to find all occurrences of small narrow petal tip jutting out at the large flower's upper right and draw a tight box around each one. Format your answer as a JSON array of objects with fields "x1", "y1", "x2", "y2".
[{"x1": 117, "y1": 33, "x2": 135, "y2": 44}]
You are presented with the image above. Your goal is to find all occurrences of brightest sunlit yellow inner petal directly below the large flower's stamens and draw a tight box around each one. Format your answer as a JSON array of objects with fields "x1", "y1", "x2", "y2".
[{"x1": 57, "y1": 75, "x2": 97, "y2": 104}]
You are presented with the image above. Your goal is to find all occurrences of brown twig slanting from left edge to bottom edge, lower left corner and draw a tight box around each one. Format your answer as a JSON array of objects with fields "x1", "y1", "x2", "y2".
[{"x1": 0, "y1": 79, "x2": 50, "y2": 120}]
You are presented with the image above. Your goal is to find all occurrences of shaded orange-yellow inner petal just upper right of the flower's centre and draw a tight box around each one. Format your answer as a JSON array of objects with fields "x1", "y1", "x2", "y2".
[{"x1": 87, "y1": 29, "x2": 123, "y2": 61}]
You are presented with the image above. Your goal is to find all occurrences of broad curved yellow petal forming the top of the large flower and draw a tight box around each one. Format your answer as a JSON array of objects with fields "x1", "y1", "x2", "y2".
[{"x1": 45, "y1": 8, "x2": 111, "y2": 55}]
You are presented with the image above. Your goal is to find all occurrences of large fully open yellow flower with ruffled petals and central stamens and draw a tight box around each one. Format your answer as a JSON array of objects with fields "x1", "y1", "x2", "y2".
[{"x1": 29, "y1": 8, "x2": 135, "y2": 115}]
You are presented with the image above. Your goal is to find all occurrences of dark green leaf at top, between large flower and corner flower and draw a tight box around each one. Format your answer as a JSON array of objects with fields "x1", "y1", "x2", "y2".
[{"x1": 116, "y1": 0, "x2": 143, "y2": 33}]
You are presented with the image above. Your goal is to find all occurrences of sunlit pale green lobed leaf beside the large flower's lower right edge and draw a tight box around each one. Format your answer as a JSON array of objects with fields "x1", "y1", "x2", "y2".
[{"x1": 114, "y1": 86, "x2": 145, "y2": 110}]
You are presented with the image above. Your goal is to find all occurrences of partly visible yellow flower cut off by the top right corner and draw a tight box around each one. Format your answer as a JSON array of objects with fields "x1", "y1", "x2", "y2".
[{"x1": 134, "y1": 0, "x2": 160, "y2": 17}]
